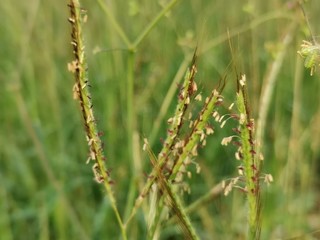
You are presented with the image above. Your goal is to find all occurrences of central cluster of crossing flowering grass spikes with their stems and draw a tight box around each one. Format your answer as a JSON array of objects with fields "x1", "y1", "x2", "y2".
[{"x1": 128, "y1": 51, "x2": 224, "y2": 239}]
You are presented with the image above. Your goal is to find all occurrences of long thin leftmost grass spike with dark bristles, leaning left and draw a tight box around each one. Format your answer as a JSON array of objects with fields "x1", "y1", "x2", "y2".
[{"x1": 68, "y1": 0, "x2": 127, "y2": 239}]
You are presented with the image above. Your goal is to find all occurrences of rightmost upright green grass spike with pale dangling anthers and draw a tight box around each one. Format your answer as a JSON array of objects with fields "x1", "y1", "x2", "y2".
[{"x1": 221, "y1": 75, "x2": 273, "y2": 240}]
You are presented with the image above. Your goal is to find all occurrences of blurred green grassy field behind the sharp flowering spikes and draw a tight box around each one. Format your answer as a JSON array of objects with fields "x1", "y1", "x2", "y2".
[{"x1": 0, "y1": 0, "x2": 320, "y2": 240}]
